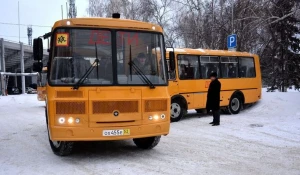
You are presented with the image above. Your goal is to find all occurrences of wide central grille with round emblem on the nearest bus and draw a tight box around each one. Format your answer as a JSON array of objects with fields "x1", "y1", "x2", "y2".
[{"x1": 93, "y1": 101, "x2": 139, "y2": 114}]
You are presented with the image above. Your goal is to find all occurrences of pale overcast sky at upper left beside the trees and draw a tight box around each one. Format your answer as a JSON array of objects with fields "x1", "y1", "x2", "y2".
[{"x1": 0, "y1": 0, "x2": 88, "y2": 44}]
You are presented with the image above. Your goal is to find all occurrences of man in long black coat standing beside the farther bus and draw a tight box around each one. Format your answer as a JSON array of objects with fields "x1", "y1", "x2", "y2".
[{"x1": 206, "y1": 72, "x2": 221, "y2": 126}]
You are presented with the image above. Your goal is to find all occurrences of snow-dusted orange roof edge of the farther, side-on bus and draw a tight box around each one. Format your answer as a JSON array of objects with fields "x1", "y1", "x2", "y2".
[{"x1": 167, "y1": 48, "x2": 255, "y2": 58}]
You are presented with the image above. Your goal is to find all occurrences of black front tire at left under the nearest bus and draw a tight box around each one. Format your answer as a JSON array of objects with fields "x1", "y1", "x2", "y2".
[{"x1": 45, "y1": 110, "x2": 74, "y2": 156}]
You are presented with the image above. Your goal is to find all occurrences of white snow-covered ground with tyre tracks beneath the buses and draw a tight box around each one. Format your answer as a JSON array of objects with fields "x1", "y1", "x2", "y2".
[{"x1": 0, "y1": 90, "x2": 300, "y2": 175}]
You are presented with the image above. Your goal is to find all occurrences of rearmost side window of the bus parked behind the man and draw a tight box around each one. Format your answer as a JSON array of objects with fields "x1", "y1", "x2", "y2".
[{"x1": 239, "y1": 57, "x2": 256, "y2": 78}]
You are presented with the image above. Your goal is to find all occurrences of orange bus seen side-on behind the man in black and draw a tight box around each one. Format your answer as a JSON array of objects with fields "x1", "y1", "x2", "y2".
[{"x1": 167, "y1": 48, "x2": 262, "y2": 122}]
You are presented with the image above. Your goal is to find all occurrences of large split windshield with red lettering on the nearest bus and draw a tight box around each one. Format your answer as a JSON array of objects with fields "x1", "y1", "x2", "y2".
[{"x1": 49, "y1": 28, "x2": 167, "y2": 86}]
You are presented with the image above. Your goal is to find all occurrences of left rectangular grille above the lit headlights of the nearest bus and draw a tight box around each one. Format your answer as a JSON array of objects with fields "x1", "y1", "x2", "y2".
[{"x1": 56, "y1": 101, "x2": 85, "y2": 114}]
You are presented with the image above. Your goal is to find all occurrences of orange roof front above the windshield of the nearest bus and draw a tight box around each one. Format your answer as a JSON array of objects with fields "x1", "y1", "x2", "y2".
[{"x1": 52, "y1": 18, "x2": 163, "y2": 33}]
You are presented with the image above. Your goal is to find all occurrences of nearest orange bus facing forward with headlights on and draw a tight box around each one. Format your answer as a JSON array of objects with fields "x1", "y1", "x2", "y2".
[{"x1": 33, "y1": 14, "x2": 171, "y2": 156}]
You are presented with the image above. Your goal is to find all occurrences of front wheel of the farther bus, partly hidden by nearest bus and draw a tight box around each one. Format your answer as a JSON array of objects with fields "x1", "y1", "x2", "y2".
[{"x1": 171, "y1": 99, "x2": 186, "y2": 122}]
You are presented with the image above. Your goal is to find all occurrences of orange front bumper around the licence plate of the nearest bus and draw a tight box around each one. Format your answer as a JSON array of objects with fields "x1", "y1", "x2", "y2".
[{"x1": 50, "y1": 122, "x2": 170, "y2": 141}]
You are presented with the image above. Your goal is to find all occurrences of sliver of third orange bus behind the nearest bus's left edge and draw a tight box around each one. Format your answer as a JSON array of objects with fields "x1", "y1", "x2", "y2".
[{"x1": 37, "y1": 67, "x2": 47, "y2": 101}]
